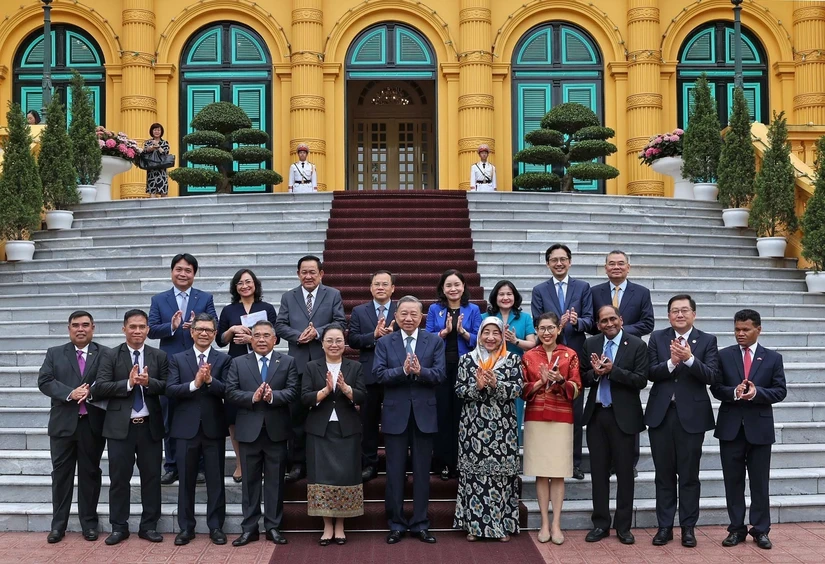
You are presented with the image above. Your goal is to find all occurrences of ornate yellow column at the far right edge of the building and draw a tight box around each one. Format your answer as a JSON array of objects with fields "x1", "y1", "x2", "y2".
[{"x1": 793, "y1": 1, "x2": 825, "y2": 125}]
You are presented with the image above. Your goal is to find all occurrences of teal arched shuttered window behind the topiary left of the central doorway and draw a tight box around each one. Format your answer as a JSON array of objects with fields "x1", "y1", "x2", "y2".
[{"x1": 179, "y1": 22, "x2": 272, "y2": 194}]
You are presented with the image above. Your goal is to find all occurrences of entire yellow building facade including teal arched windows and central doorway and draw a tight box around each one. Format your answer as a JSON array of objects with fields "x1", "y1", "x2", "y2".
[{"x1": 0, "y1": 0, "x2": 825, "y2": 198}]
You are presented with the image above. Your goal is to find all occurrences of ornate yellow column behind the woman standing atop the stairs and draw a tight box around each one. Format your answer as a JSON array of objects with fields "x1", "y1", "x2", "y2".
[{"x1": 119, "y1": 0, "x2": 158, "y2": 199}]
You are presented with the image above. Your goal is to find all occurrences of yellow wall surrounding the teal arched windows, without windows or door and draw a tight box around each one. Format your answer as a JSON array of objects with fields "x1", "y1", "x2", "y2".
[{"x1": 0, "y1": 0, "x2": 812, "y2": 198}]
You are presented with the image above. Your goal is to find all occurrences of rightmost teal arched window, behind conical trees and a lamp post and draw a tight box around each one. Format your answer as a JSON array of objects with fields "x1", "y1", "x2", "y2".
[{"x1": 676, "y1": 21, "x2": 770, "y2": 127}]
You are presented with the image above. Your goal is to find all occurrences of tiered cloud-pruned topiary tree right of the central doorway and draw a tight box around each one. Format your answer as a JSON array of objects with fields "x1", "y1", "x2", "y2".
[{"x1": 513, "y1": 102, "x2": 619, "y2": 192}]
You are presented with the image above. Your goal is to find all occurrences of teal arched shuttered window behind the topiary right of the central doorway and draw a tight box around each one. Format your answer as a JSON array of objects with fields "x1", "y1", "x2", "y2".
[{"x1": 513, "y1": 22, "x2": 604, "y2": 192}]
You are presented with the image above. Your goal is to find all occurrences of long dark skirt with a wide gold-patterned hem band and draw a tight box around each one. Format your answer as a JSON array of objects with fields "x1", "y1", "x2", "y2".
[{"x1": 307, "y1": 421, "x2": 364, "y2": 518}]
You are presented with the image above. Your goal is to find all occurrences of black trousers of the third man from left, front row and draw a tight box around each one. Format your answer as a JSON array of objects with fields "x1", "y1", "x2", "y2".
[{"x1": 175, "y1": 427, "x2": 226, "y2": 531}]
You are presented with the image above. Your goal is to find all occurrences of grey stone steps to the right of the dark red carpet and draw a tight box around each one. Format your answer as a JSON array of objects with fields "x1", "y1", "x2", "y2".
[{"x1": 468, "y1": 193, "x2": 825, "y2": 528}]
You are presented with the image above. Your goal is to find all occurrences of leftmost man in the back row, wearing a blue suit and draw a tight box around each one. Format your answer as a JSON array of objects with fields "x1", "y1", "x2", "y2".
[{"x1": 149, "y1": 253, "x2": 218, "y2": 485}]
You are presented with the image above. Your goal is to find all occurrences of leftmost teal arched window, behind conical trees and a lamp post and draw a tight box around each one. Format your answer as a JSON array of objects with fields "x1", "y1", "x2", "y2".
[{"x1": 12, "y1": 24, "x2": 106, "y2": 125}]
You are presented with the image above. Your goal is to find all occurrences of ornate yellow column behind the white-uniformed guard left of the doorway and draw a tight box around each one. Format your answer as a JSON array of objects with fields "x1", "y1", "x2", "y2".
[{"x1": 289, "y1": 0, "x2": 326, "y2": 191}]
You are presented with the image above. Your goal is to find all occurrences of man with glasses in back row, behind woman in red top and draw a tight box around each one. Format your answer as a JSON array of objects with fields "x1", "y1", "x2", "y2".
[{"x1": 530, "y1": 243, "x2": 593, "y2": 480}]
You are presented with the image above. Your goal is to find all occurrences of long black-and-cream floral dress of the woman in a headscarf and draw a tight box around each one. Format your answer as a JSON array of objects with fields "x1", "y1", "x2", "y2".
[{"x1": 453, "y1": 353, "x2": 522, "y2": 538}]
